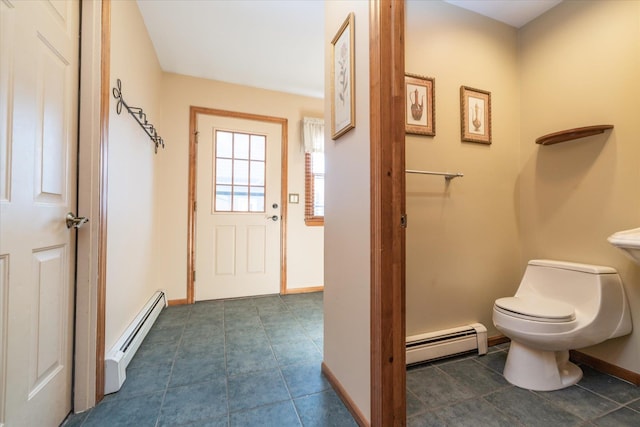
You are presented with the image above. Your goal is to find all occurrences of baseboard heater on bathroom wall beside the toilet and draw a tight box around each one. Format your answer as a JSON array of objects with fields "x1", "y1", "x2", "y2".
[{"x1": 406, "y1": 323, "x2": 487, "y2": 365}]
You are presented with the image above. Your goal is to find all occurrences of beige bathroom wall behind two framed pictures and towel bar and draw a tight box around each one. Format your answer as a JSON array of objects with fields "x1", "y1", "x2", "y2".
[{"x1": 405, "y1": 1, "x2": 522, "y2": 336}]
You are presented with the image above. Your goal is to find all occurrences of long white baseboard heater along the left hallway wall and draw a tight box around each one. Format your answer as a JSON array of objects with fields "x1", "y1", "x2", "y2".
[{"x1": 104, "y1": 291, "x2": 167, "y2": 394}]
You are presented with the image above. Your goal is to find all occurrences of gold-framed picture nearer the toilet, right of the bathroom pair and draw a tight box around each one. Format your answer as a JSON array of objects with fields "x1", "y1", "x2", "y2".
[{"x1": 460, "y1": 86, "x2": 491, "y2": 144}]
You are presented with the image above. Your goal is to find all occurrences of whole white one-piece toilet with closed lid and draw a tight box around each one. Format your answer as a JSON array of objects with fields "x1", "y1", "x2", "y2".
[{"x1": 493, "y1": 260, "x2": 632, "y2": 391}]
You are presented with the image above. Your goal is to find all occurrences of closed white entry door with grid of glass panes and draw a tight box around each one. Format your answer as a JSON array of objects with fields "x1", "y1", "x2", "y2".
[{"x1": 195, "y1": 115, "x2": 282, "y2": 301}]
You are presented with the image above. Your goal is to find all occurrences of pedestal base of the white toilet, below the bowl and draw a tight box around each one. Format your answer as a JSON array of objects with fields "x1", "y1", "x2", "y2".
[{"x1": 504, "y1": 341, "x2": 582, "y2": 391}]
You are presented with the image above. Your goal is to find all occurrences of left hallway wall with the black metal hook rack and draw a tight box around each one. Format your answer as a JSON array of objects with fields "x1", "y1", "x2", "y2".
[{"x1": 105, "y1": 1, "x2": 162, "y2": 351}]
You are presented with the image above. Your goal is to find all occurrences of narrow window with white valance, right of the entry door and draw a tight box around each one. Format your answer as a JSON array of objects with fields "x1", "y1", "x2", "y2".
[{"x1": 302, "y1": 117, "x2": 324, "y2": 226}]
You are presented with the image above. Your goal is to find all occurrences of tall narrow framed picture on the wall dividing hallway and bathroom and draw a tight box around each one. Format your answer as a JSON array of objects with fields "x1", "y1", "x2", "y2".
[{"x1": 331, "y1": 12, "x2": 356, "y2": 140}]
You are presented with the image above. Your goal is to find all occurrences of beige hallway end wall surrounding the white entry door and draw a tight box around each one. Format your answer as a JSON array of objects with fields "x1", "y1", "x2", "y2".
[{"x1": 155, "y1": 73, "x2": 324, "y2": 300}]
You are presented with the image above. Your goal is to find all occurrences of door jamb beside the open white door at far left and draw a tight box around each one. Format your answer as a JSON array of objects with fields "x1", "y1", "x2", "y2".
[{"x1": 73, "y1": 0, "x2": 111, "y2": 412}]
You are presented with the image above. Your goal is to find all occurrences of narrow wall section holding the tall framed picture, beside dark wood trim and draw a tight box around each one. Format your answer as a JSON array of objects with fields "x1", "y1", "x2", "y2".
[{"x1": 324, "y1": 2, "x2": 371, "y2": 419}]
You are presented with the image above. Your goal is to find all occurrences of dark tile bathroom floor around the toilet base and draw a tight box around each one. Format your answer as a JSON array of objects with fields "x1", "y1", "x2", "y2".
[{"x1": 407, "y1": 344, "x2": 640, "y2": 427}]
